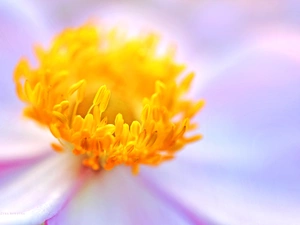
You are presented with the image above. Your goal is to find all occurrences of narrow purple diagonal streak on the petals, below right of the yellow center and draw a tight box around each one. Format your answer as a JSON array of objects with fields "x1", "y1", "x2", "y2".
[{"x1": 137, "y1": 173, "x2": 216, "y2": 225}]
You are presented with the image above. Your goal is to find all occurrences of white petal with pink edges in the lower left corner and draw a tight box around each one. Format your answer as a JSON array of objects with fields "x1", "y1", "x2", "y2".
[{"x1": 0, "y1": 154, "x2": 86, "y2": 225}]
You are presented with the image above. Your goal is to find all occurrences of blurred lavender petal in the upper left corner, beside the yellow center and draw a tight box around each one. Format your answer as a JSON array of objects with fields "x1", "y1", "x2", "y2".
[{"x1": 0, "y1": 0, "x2": 46, "y2": 111}]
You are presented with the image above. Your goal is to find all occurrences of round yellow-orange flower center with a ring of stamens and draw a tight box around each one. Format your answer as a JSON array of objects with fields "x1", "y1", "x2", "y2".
[{"x1": 14, "y1": 24, "x2": 204, "y2": 173}]
